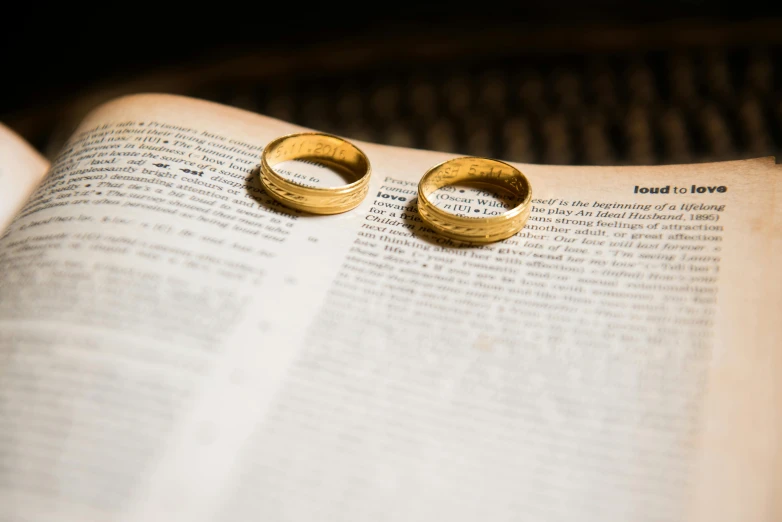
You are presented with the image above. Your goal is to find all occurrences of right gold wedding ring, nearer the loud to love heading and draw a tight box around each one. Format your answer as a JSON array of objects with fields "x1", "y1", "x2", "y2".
[{"x1": 418, "y1": 157, "x2": 532, "y2": 244}]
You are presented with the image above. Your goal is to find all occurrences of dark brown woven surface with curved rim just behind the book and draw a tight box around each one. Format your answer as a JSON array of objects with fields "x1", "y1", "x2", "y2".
[{"x1": 3, "y1": 20, "x2": 782, "y2": 165}]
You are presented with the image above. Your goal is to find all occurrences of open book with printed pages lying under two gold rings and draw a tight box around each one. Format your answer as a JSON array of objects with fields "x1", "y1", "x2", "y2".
[{"x1": 0, "y1": 95, "x2": 782, "y2": 522}]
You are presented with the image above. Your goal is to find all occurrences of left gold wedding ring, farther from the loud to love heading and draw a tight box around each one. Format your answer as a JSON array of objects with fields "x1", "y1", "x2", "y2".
[{"x1": 261, "y1": 132, "x2": 370, "y2": 214}]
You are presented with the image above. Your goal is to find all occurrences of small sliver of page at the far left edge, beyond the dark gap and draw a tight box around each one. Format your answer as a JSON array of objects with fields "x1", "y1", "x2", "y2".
[{"x1": 0, "y1": 123, "x2": 49, "y2": 233}]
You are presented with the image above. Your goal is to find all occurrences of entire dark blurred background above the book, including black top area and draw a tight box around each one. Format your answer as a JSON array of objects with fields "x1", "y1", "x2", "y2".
[{"x1": 0, "y1": 0, "x2": 782, "y2": 165}]
